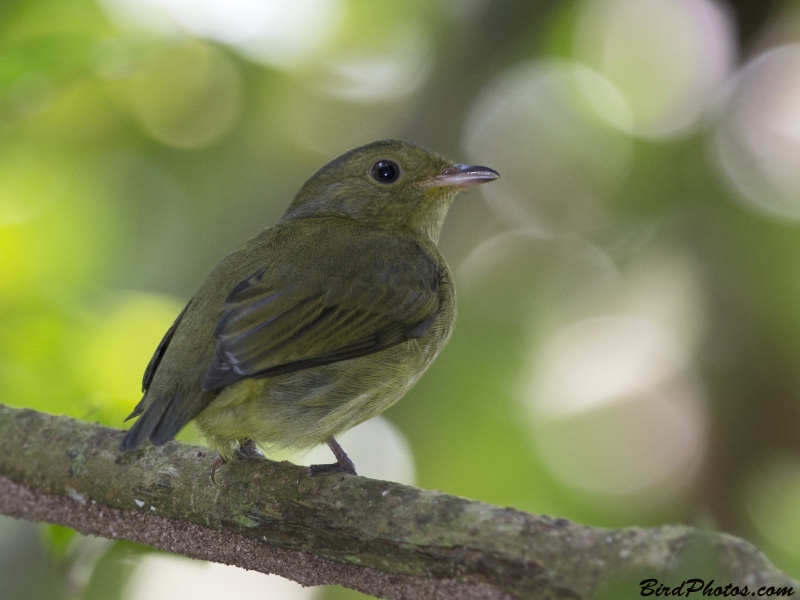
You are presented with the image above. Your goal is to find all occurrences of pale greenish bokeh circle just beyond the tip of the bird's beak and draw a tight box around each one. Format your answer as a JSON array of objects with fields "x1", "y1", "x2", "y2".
[{"x1": 464, "y1": 61, "x2": 632, "y2": 232}]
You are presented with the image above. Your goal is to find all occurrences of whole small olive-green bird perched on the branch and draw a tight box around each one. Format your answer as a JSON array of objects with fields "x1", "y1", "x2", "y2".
[{"x1": 120, "y1": 140, "x2": 499, "y2": 476}]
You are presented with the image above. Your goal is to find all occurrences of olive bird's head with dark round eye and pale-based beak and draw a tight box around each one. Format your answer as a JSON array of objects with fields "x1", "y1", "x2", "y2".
[{"x1": 283, "y1": 140, "x2": 500, "y2": 241}]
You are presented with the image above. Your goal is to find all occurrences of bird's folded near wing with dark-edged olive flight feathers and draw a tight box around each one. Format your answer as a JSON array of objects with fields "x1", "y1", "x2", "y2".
[{"x1": 202, "y1": 234, "x2": 439, "y2": 391}]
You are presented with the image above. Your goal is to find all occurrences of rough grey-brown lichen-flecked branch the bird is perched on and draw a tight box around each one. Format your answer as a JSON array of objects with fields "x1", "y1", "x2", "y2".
[{"x1": 0, "y1": 405, "x2": 800, "y2": 600}]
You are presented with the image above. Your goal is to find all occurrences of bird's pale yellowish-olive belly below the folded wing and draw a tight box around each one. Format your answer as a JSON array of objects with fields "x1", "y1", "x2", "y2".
[{"x1": 197, "y1": 335, "x2": 445, "y2": 455}]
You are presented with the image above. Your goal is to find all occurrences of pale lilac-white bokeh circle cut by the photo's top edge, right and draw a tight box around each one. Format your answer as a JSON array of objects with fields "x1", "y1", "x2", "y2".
[{"x1": 574, "y1": 0, "x2": 736, "y2": 137}]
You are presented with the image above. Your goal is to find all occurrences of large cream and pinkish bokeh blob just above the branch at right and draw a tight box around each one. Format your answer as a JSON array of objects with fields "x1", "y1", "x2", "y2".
[{"x1": 522, "y1": 315, "x2": 705, "y2": 505}]
